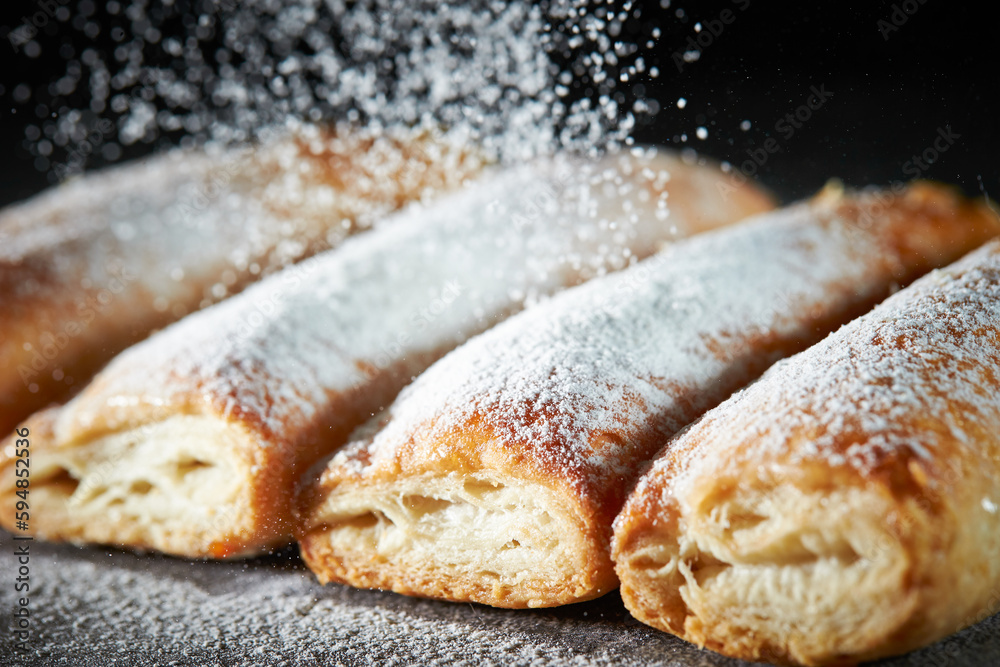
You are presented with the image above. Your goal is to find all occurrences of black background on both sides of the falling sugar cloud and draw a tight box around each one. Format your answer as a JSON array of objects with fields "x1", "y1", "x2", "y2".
[{"x1": 0, "y1": 0, "x2": 1000, "y2": 203}]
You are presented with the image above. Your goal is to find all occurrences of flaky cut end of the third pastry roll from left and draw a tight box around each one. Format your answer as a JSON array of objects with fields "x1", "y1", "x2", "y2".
[{"x1": 300, "y1": 474, "x2": 617, "y2": 608}]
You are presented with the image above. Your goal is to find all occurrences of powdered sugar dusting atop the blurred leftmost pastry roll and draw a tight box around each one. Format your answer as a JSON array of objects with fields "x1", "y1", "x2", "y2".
[{"x1": 0, "y1": 125, "x2": 481, "y2": 310}]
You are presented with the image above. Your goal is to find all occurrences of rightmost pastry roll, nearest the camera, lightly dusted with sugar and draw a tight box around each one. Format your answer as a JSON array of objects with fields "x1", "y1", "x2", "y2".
[{"x1": 614, "y1": 237, "x2": 1000, "y2": 665}]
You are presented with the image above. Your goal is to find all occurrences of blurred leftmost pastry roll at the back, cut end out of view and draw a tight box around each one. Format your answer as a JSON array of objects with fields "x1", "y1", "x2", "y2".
[{"x1": 0, "y1": 127, "x2": 480, "y2": 437}]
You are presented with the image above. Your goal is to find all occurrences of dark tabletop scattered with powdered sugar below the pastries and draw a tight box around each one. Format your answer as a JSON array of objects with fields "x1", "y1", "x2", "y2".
[{"x1": 0, "y1": 532, "x2": 1000, "y2": 667}]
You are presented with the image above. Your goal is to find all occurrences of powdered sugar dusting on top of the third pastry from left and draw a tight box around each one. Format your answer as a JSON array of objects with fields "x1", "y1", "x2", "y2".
[{"x1": 333, "y1": 204, "x2": 916, "y2": 500}]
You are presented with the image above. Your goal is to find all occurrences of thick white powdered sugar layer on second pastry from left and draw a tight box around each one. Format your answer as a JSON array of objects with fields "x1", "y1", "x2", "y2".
[{"x1": 61, "y1": 151, "x2": 684, "y2": 446}]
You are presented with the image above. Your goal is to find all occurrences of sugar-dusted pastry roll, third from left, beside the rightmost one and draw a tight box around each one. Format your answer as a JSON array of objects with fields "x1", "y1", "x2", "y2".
[{"x1": 300, "y1": 185, "x2": 996, "y2": 607}]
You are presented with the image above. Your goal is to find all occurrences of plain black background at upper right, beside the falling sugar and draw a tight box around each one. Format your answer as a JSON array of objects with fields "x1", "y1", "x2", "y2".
[{"x1": 628, "y1": 0, "x2": 1000, "y2": 202}]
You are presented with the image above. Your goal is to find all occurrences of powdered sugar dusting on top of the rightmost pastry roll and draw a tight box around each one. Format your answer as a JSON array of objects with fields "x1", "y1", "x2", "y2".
[{"x1": 664, "y1": 242, "x2": 1000, "y2": 495}]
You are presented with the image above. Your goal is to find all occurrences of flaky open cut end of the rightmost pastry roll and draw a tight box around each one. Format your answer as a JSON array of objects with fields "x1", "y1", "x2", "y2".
[{"x1": 614, "y1": 485, "x2": 927, "y2": 665}]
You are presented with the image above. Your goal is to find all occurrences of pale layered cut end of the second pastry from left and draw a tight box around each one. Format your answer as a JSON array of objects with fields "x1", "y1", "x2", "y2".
[{"x1": 0, "y1": 409, "x2": 282, "y2": 558}]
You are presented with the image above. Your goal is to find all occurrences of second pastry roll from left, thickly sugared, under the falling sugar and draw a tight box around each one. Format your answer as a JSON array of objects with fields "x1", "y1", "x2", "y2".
[{"x1": 0, "y1": 147, "x2": 768, "y2": 557}]
